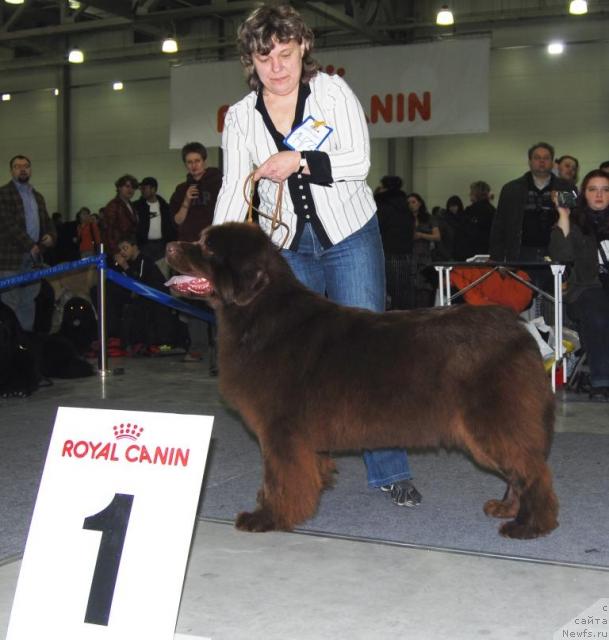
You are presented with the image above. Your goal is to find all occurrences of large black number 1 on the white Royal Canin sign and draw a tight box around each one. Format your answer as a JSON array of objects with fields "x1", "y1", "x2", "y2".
[{"x1": 82, "y1": 493, "x2": 133, "y2": 626}]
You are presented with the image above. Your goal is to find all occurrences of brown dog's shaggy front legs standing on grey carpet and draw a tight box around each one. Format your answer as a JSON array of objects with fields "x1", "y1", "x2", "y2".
[{"x1": 235, "y1": 438, "x2": 332, "y2": 531}]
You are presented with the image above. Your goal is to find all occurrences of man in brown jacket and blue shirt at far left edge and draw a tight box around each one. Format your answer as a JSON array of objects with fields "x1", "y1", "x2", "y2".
[{"x1": 0, "y1": 155, "x2": 56, "y2": 331}]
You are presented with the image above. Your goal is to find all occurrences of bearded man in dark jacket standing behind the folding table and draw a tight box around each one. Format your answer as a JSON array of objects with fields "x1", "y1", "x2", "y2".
[{"x1": 490, "y1": 142, "x2": 573, "y2": 262}]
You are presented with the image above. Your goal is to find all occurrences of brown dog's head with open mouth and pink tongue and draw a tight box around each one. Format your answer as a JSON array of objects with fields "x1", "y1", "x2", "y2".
[{"x1": 166, "y1": 222, "x2": 282, "y2": 306}]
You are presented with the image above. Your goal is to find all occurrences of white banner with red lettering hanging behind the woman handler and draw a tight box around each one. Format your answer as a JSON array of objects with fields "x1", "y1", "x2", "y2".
[{"x1": 170, "y1": 38, "x2": 490, "y2": 149}]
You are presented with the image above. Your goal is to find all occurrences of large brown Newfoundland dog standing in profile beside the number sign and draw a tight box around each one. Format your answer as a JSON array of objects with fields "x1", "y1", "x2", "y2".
[{"x1": 167, "y1": 223, "x2": 558, "y2": 538}]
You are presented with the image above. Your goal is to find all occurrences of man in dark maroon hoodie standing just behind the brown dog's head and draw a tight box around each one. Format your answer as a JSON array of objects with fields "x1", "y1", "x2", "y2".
[{"x1": 169, "y1": 142, "x2": 222, "y2": 362}]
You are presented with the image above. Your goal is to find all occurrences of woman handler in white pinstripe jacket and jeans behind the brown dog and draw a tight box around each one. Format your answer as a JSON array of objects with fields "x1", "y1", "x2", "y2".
[{"x1": 214, "y1": 4, "x2": 420, "y2": 506}]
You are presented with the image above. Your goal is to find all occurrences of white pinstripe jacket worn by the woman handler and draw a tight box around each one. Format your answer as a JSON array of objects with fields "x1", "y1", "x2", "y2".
[{"x1": 214, "y1": 72, "x2": 376, "y2": 247}]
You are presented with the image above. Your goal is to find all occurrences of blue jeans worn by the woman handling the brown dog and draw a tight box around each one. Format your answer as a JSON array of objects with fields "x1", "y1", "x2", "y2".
[{"x1": 282, "y1": 216, "x2": 412, "y2": 487}]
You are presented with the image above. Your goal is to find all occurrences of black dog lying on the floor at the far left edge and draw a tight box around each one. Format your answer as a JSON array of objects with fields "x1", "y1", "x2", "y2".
[{"x1": 0, "y1": 302, "x2": 94, "y2": 397}]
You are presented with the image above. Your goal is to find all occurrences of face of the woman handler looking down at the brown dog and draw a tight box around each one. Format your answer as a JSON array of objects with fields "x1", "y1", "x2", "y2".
[{"x1": 252, "y1": 40, "x2": 305, "y2": 96}]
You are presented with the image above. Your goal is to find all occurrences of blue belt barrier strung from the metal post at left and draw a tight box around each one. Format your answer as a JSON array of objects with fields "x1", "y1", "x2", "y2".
[{"x1": 0, "y1": 253, "x2": 216, "y2": 323}]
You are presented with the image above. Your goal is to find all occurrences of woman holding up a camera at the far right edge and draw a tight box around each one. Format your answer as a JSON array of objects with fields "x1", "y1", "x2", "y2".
[{"x1": 550, "y1": 169, "x2": 609, "y2": 402}]
